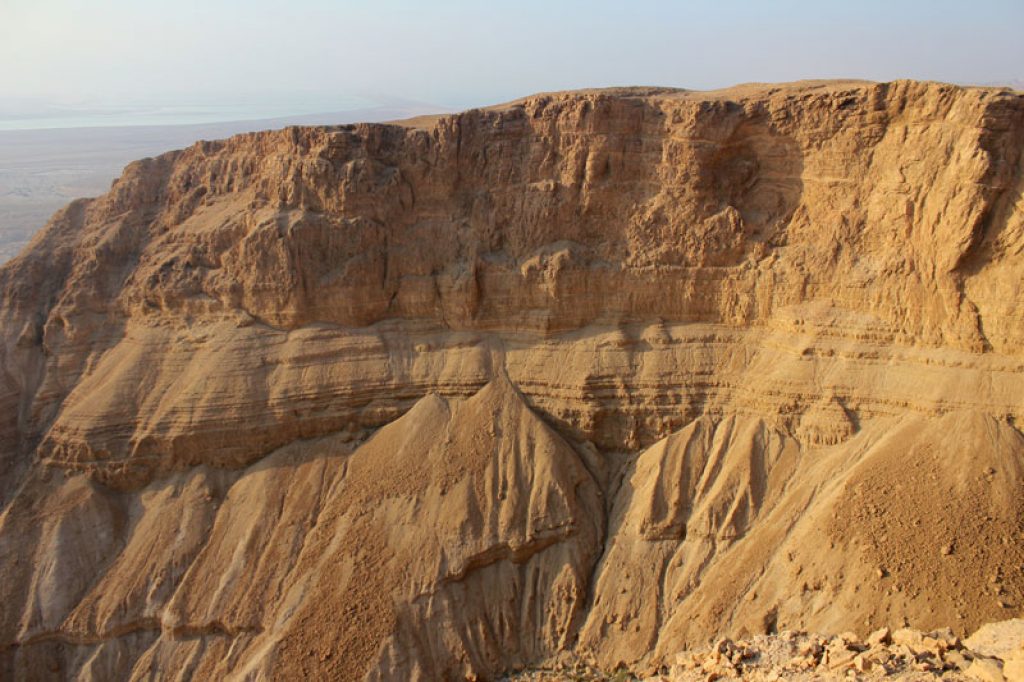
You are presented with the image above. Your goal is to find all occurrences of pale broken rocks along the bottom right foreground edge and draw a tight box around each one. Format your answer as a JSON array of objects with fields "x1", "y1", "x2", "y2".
[{"x1": 506, "y1": 620, "x2": 1024, "y2": 682}]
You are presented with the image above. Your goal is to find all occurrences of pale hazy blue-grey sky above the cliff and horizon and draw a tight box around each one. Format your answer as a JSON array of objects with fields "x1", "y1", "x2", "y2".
[{"x1": 0, "y1": 0, "x2": 1024, "y2": 106}]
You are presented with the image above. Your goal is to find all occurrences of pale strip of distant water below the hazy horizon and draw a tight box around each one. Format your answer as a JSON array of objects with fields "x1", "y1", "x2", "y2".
[{"x1": 0, "y1": 96, "x2": 380, "y2": 130}]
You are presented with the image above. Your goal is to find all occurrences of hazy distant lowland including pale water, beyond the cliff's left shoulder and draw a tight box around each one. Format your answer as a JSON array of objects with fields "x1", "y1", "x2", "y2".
[{"x1": 0, "y1": 96, "x2": 445, "y2": 264}]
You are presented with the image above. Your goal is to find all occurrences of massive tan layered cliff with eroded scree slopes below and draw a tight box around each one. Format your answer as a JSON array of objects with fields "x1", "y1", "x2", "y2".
[{"x1": 0, "y1": 82, "x2": 1024, "y2": 680}]
